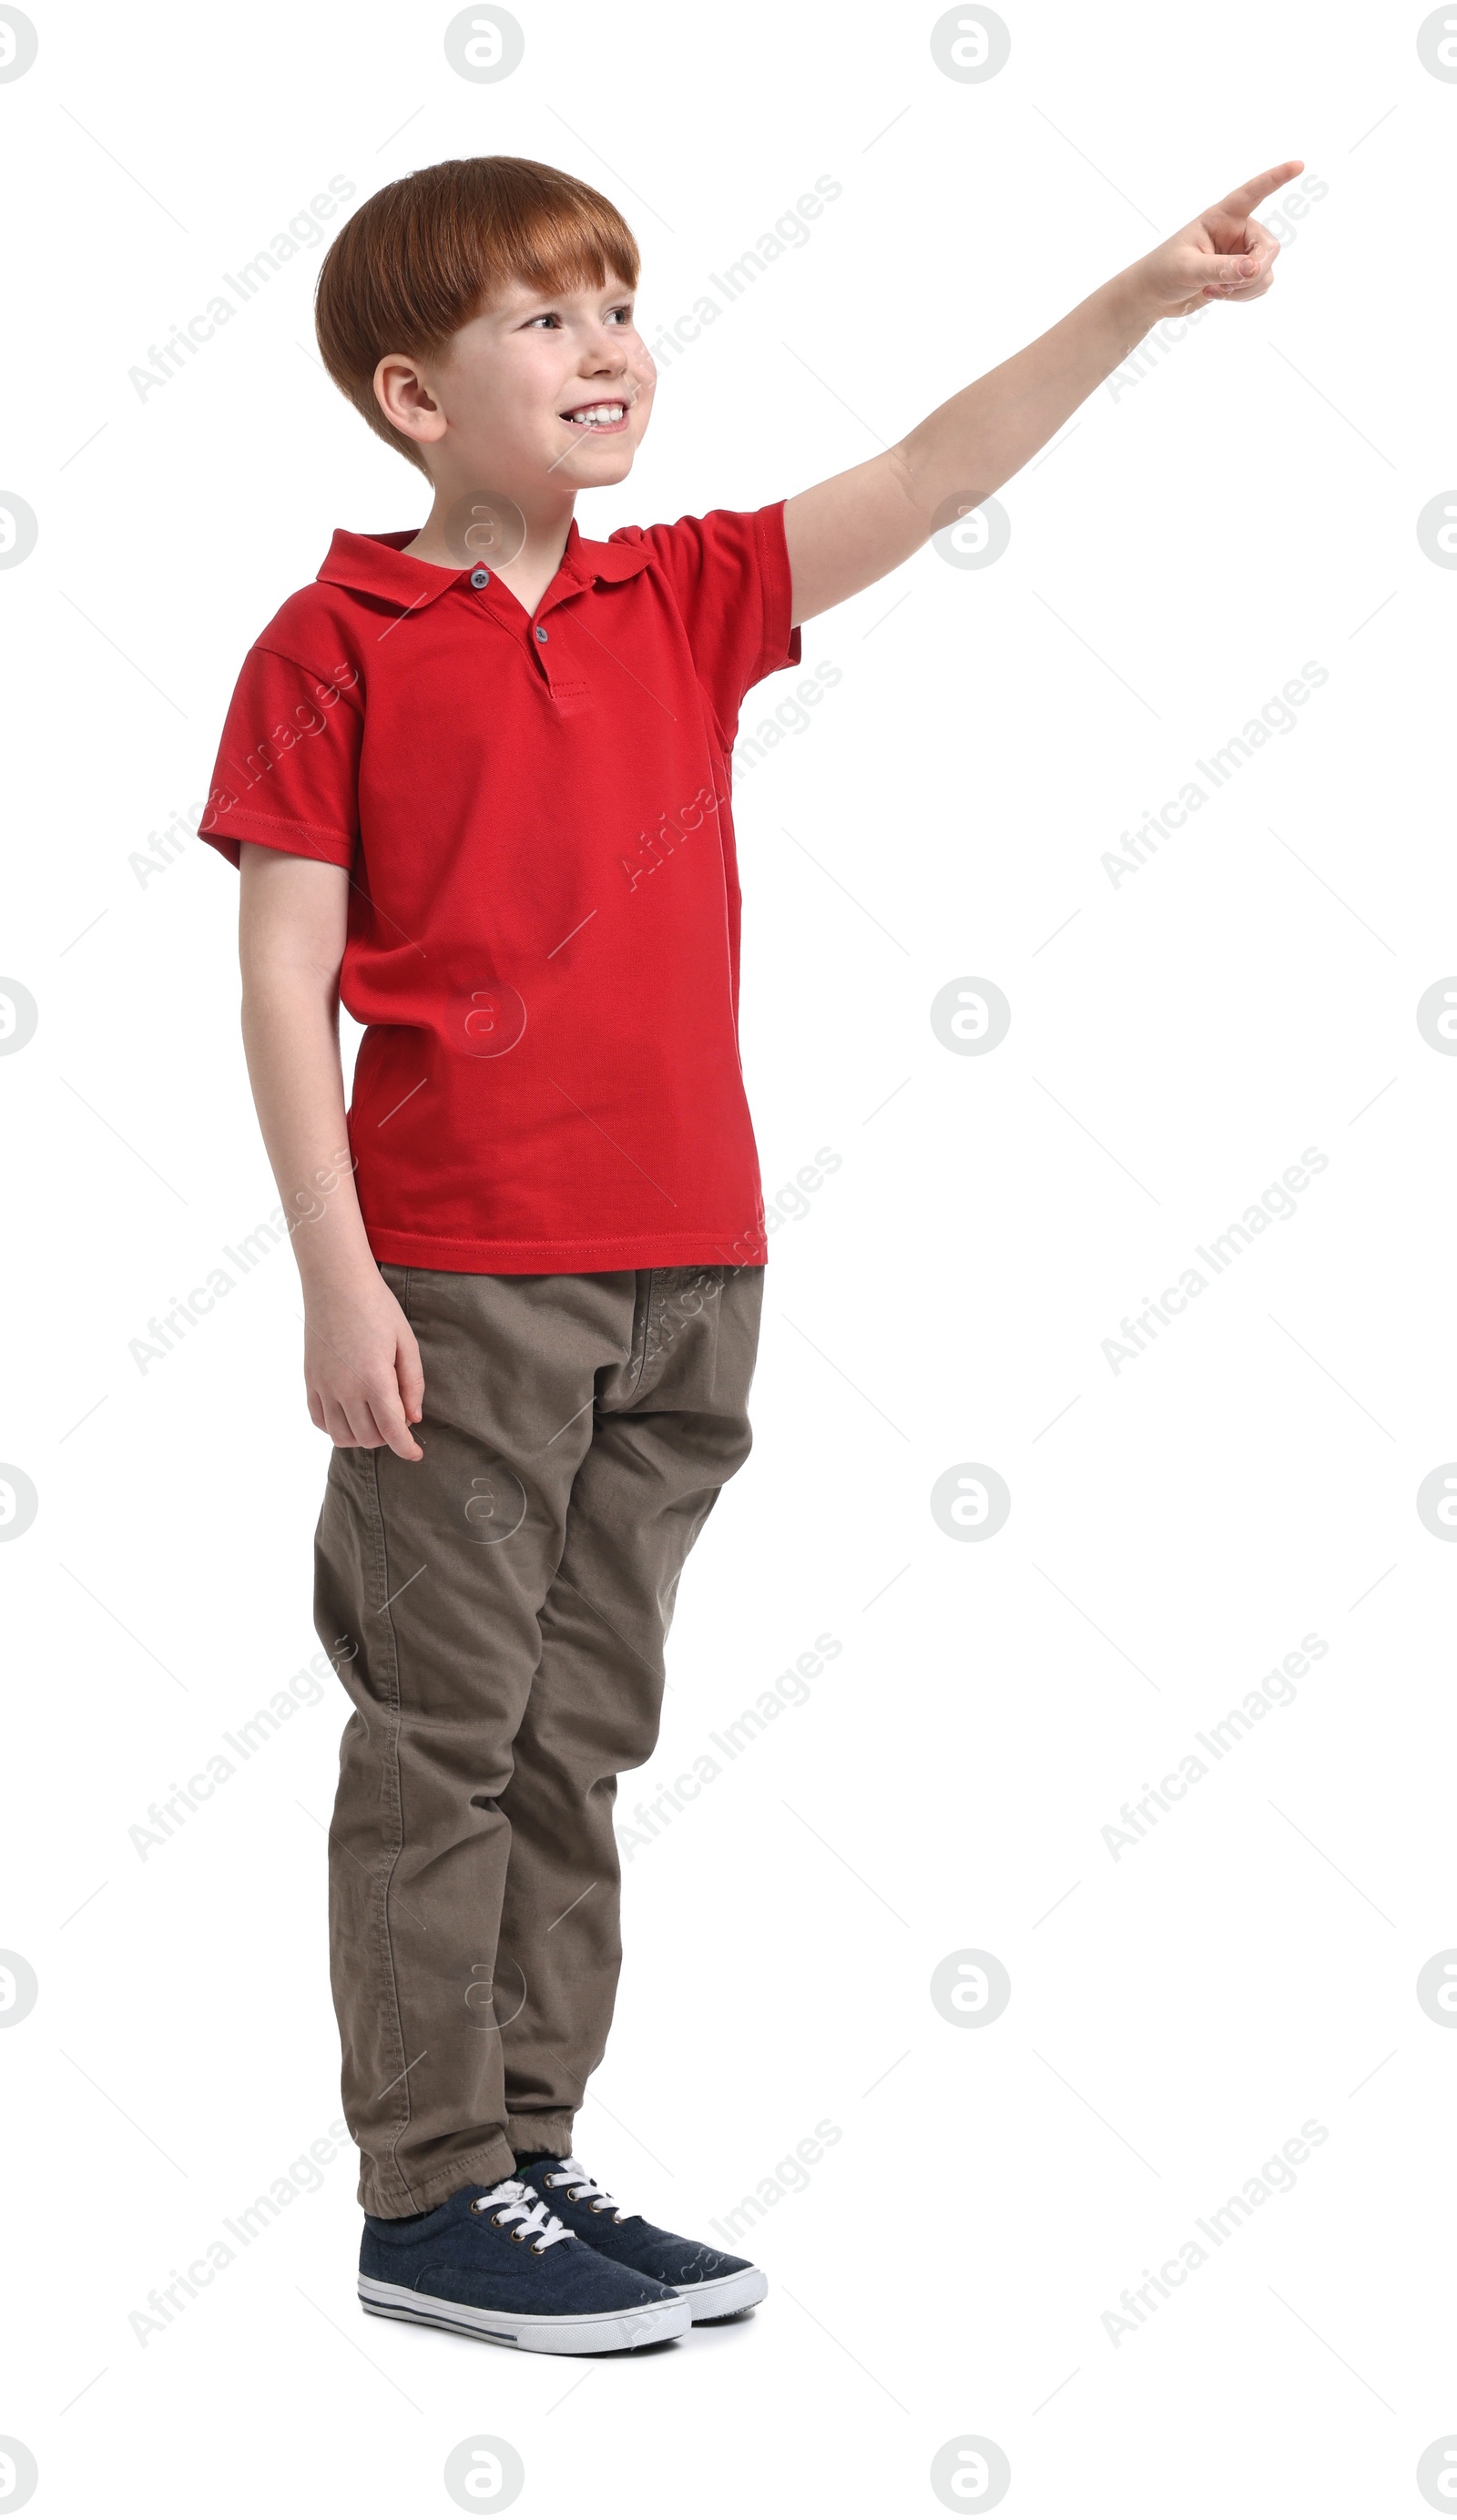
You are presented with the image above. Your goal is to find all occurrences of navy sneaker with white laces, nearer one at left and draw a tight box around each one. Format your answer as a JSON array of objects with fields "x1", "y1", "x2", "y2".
[{"x1": 358, "y1": 2180, "x2": 690, "y2": 2353}]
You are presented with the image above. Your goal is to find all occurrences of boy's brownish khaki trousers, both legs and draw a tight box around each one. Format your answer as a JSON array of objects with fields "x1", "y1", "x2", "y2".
[{"x1": 315, "y1": 1265, "x2": 764, "y2": 2215}]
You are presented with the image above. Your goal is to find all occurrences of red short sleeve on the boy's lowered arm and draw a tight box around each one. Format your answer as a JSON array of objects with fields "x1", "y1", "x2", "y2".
[{"x1": 197, "y1": 647, "x2": 363, "y2": 867}]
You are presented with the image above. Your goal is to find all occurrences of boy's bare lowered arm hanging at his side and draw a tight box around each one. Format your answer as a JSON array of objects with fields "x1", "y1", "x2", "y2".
[{"x1": 239, "y1": 842, "x2": 423, "y2": 1461}]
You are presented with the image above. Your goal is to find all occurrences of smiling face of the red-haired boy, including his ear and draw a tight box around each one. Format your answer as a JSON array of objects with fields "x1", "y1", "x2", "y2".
[{"x1": 375, "y1": 275, "x2": 657, "y2": 509}]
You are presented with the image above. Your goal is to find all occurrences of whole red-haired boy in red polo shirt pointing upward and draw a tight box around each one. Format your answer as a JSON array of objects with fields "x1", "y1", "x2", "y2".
[{"x1": 201, "y1": 157, "x2": 1300, "y2": 2353}]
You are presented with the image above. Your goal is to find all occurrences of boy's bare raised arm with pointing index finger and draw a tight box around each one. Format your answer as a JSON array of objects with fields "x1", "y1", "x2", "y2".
[{"x1": 784, "y1": 158, "x2": 1303, "y2": 623}]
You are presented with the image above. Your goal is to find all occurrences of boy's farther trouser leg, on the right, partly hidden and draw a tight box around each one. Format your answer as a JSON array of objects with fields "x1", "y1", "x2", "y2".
[{"x1": 496, "y1": 1267, "x2": 764, "y2": 2157}]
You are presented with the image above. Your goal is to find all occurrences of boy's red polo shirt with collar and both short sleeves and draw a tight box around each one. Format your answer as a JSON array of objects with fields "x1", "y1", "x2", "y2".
[{"x1": 201, "y1": 502, "x2": 800, "y2": 1275}]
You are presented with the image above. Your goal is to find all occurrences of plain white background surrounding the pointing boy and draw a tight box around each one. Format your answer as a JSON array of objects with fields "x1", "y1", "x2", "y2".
[{"x1": 0, "y1": 0, "x2": 1457, "y2": 2520}]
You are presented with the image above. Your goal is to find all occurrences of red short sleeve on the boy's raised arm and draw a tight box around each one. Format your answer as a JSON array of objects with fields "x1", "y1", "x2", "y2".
[{"x1": 607, "y1": 499, "x2": 800, "y2": 744}]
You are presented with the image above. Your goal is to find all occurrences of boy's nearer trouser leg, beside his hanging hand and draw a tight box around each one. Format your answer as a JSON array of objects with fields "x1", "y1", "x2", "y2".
[{"x1": 315, "y1": 1265, "x2": 637, "y2": 2215}]
